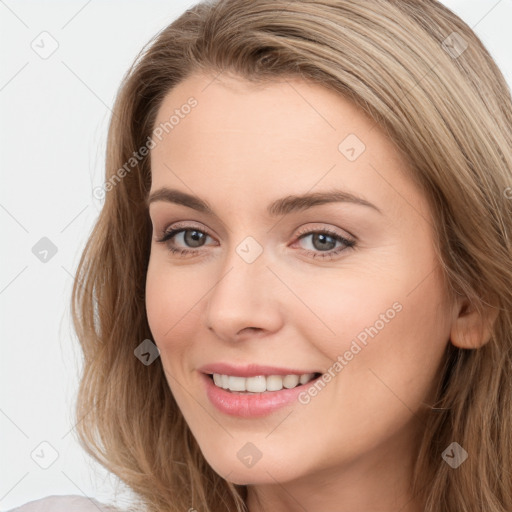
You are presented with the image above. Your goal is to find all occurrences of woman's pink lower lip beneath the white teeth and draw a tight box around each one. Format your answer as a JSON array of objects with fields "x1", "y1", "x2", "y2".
[{"x1": 201, "y1": 373, "x2": 320, "y2": 418}]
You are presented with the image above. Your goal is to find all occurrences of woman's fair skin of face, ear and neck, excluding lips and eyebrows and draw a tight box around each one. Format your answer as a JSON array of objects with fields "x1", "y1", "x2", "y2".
[{"x1": 146, "y1": 73, "x2": 488, "y2": 512}]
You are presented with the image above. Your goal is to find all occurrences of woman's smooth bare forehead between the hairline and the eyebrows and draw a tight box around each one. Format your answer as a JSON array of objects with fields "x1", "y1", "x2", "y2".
[{"x1": 151, "y1": 74, "x2": 428, "y2": 222}]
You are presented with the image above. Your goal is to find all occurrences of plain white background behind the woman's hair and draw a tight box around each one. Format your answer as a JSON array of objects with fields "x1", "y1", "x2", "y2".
[{"x1": 0, "y1": 0, "x2": 512, "y2": 510}]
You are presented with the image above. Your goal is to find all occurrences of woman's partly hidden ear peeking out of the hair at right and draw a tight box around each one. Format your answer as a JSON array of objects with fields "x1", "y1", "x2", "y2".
[{"x1": 450, "y1": 298, "x2": 499, "y2": 349}]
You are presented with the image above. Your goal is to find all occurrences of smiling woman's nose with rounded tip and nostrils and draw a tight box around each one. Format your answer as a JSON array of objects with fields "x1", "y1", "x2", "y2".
[{"x1": 205, "y1": 245, "x2": 284, "y2": 342}]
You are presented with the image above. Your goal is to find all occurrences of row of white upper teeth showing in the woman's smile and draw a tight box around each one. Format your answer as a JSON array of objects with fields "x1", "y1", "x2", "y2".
[{"x1": 213, "y1": 373, "x2": 315, "y2": 393}]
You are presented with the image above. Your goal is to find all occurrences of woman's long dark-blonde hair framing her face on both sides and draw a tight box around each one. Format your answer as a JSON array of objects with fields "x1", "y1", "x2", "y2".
[{"x1": 72, "y1": 0, "x2": 512, "y2": 512}]
